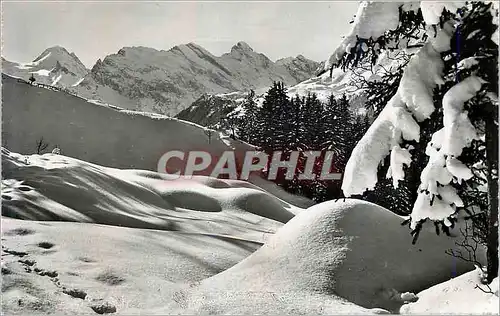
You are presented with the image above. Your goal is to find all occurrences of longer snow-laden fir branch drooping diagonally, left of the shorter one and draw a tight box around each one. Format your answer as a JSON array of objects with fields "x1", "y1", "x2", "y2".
[{"x1": 342, "y1": 23, "x2": 454, "y2": 196}]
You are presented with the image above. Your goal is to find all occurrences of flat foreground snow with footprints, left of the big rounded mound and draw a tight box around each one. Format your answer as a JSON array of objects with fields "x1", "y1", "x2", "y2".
[{"x1": 2, "y1": 217, "x2": 264, "y2": 315}]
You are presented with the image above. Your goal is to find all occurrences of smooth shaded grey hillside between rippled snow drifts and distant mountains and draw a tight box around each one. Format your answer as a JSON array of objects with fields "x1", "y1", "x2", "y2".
[{"x1": 2, "y1": 75, "x2": 312, "y2": 207}]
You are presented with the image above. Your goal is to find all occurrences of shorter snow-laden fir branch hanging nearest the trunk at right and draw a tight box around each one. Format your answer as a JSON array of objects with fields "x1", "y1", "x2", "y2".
[{"x1": 411, "y1": 76, "x2": 484, "y2": 229}]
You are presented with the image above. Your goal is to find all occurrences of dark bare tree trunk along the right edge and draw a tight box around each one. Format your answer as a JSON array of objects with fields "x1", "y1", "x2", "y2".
[{"x1": 485, "y1": 115, "x2": 498, "y2": 282}]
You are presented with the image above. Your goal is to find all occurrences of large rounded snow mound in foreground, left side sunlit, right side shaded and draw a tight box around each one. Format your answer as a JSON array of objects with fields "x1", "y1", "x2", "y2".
[{"x1": 184, "y1": 200, "x2": 480, "y2": 314}]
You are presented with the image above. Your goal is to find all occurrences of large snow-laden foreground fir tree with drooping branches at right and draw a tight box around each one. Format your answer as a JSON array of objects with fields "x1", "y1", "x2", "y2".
[{"x1": 338, "y1": 2, "x2": 498, "y2": 280}]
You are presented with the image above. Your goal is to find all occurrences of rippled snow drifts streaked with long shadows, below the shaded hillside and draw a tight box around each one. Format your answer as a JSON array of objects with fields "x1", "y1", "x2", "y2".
[{"x1": 2, "y1": 148, "x2": 300, "y2": 241}]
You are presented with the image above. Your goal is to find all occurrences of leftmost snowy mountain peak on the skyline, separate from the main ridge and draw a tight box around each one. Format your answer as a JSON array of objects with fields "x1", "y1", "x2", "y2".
[{"x1": 2, "y1": 46, "x2": 89, "y2": 88}]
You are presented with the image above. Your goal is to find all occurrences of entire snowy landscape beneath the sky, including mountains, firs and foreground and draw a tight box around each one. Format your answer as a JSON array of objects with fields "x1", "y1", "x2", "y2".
[{"x1": 1, "y1": 1, "x2": 500, "y2": 315}]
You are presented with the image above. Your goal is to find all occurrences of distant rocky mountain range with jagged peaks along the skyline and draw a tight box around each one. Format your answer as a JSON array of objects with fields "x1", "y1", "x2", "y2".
[{"x1": 2, "y1": 42, "x2": 321, "y2": 116}]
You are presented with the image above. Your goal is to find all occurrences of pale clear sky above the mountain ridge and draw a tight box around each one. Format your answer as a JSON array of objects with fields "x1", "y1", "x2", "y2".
[{"x1": 2, "y1": 1, "x2": 358, "y2": 68}]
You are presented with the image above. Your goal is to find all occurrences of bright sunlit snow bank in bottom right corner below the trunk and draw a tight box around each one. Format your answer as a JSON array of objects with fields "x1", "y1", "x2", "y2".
[{"x1": 400, "y1": 270, "x2": 499, "y2": 315}]
